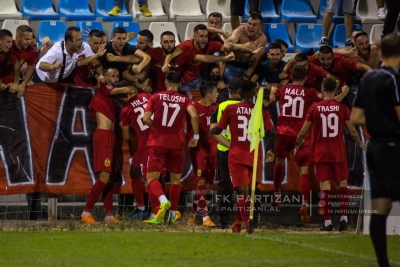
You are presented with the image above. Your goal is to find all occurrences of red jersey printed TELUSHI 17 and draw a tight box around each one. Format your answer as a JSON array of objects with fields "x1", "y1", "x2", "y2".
[{"x1": 146, "y1": 90, "x2": 193, "y2": 149}]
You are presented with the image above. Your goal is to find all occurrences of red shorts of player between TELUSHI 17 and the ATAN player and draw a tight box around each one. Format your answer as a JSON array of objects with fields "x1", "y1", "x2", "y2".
[{"x1": 190, "y1": 153, "x2": 217, "y2": 184}]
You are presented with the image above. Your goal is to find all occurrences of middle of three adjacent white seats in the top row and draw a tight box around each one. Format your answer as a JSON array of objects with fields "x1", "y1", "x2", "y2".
[{"x1": 169, "y1": 0, "x2": 206, "y2": 21}]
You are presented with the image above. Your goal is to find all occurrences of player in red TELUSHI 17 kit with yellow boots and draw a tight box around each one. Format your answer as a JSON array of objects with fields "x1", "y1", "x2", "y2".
[{"x1": 143, "y1": 71, "x2": 199, "y2": 224}]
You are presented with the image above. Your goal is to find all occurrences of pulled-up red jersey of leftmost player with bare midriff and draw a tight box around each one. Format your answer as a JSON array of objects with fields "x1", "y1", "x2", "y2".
[{"x1": 89, "y1": 82, "x2": 117, "y2": 124}]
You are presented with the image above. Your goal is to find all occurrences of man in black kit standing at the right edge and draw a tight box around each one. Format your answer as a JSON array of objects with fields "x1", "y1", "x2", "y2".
[{"x1": 351, "y1": 34, "x2": 400, "y2": 266}]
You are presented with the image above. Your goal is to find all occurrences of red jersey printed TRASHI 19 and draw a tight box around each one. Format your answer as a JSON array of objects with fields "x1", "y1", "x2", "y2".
[{"x1": 306, "y1": 100, "x2": 350, "y2": 162}]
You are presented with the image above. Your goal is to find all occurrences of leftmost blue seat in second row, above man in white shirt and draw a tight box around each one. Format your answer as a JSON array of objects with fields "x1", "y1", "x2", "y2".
[{"x1": 37, "y1": 20, "x2": 67, "y2": 46}]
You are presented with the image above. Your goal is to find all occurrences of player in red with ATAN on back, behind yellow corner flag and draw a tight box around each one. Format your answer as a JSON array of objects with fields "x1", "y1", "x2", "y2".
[{"x1": 210, "y1": 80, "x2": 276, "y2": 233}]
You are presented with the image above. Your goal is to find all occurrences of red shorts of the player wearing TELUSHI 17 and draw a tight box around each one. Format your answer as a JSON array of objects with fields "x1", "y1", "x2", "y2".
[{"x1": 147, "y1": 146, "x2": 185, "y2": 173}]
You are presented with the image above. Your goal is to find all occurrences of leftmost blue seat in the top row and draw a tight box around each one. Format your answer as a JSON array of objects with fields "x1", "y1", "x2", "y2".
[{"x1": 22, "y1": 0, "x2": 60, "y2": 20}]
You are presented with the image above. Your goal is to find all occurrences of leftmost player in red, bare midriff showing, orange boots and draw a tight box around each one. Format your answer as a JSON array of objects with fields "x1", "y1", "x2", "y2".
[{"x1": 81, "y1": 68, "x2": 136, "y2": 224}]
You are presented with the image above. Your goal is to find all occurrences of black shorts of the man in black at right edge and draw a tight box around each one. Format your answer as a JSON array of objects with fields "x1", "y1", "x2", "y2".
[{"x1": 367, "y1": 140, "x2": 400, "y2": 201}]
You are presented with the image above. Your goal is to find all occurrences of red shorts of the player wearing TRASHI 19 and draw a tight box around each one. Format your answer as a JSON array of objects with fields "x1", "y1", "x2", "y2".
[{"x1": 314, "y1": 160, "x2": 349, "y2": 182}]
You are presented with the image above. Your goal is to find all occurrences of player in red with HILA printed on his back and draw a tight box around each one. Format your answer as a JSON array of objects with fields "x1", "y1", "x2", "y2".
[{"x1": 121, "y1": 88, "x2": 151, "y2": 220}]
